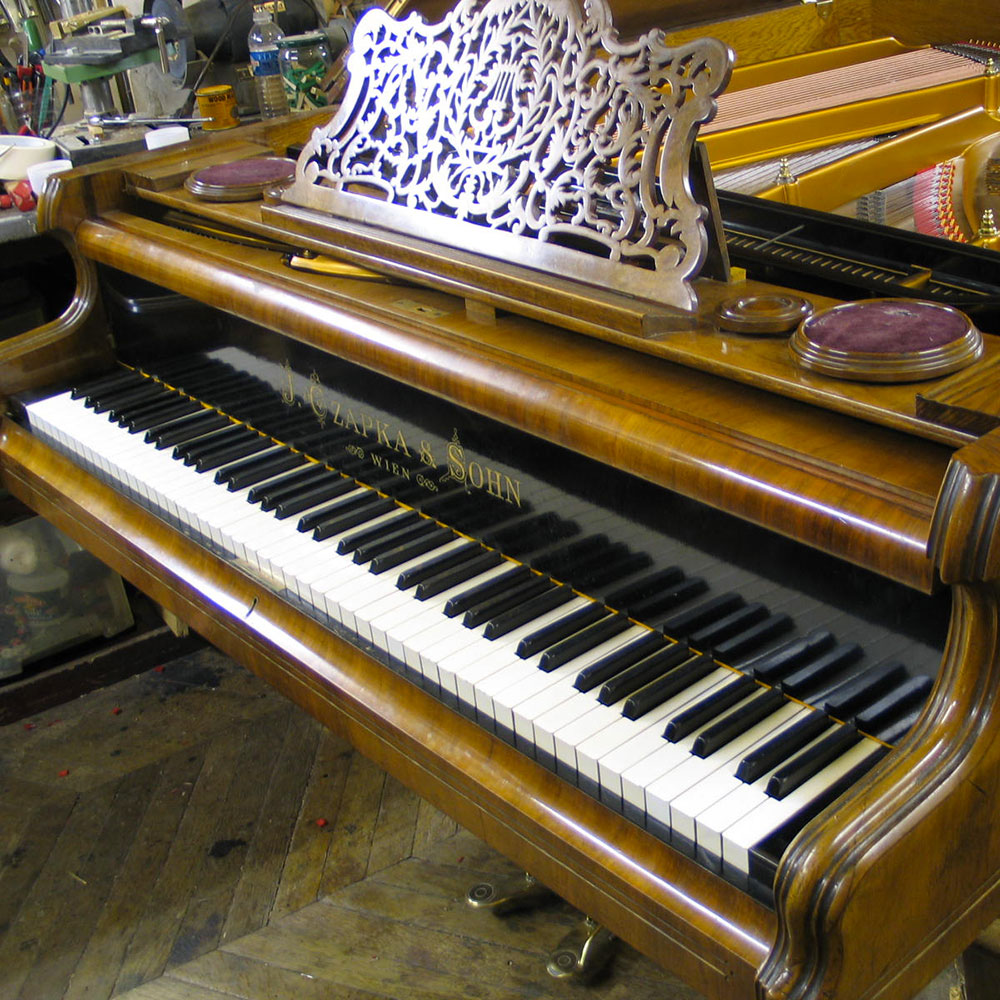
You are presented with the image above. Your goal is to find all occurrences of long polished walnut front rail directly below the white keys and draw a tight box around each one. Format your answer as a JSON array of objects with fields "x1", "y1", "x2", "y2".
[{"x1": 0, "y1": 421, "x2": 774, "y2": 1000}]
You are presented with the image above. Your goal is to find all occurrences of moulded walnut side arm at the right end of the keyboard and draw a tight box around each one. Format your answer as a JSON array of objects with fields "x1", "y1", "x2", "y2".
[{"x1": 759, "y1": 432, "x2": 1000, "y2": 1000}]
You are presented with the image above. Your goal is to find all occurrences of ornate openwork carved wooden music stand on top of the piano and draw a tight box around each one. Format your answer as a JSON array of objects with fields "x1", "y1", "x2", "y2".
[{"x1": 283, "y1": 0, "x2": 731, "y2": 308}]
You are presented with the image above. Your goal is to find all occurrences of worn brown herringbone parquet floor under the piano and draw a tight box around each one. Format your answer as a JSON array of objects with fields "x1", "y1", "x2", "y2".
[{"x1": 0, "y1": 649, "x2": 698, "y2": 1000}]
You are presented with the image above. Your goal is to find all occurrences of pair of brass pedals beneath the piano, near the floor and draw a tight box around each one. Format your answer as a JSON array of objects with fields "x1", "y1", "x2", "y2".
[{"x1": 466, "y1": 872, "x2": 617, "y2": 981}]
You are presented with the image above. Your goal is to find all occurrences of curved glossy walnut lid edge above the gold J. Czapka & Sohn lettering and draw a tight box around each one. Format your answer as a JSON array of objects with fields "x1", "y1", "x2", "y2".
[{"x1": 66, "y1": 206, "x2": 951, "y2": 590}]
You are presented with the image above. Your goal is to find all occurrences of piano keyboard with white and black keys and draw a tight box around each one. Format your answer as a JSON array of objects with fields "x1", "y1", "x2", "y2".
[{"x1": 24, "y1": 364, "x2": 931, "y2": 899}]
